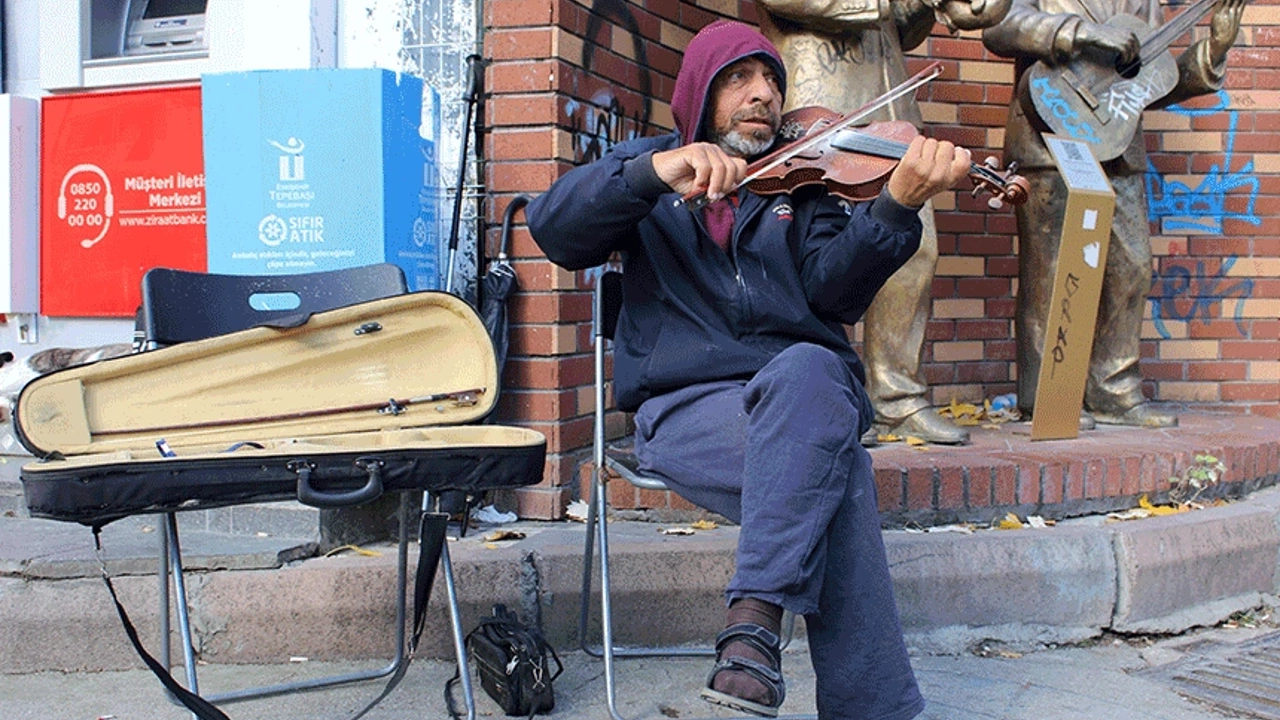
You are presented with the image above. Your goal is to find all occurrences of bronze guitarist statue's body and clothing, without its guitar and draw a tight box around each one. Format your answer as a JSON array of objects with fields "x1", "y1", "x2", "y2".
[{"x1": 982, "y1": 0, "x2": 1245, "y2": 428}]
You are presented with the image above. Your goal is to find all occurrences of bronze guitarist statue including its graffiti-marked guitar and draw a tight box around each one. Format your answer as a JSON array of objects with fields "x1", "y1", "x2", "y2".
[{"x1": 983, "y1": 0, "x2": 1247, "y2": 428}]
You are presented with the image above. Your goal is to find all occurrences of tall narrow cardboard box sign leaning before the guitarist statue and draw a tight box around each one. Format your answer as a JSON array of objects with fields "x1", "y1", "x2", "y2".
[{"x1": 1032, "y1": 135, "x2": 1116, "y2": 439}]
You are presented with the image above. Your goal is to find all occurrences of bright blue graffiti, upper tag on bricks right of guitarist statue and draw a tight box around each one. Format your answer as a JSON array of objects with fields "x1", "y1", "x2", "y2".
[{"x1": 1146, "y1": 91, "x2": 1262, "y2": 233}]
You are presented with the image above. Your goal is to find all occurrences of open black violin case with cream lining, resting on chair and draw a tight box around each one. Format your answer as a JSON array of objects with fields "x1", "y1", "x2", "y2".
[{"x1": 14, "y1": 292, "x2": 547, "y2": 528}]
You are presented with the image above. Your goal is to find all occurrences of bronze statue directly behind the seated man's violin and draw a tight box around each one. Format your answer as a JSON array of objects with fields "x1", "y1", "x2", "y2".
[{"x1": 758, "y1": 0, "x2": 1010, "y2": 445}]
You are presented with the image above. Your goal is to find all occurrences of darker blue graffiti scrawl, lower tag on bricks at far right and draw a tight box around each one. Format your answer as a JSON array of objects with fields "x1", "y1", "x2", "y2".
[{"x1": 1151, "y1": 255, "x2": 1253, "y2": 340}]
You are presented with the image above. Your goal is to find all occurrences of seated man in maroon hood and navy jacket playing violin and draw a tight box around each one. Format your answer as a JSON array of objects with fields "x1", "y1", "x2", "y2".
[{"x1": 526, "y1": 22, "x2": 969, "y2": 720}]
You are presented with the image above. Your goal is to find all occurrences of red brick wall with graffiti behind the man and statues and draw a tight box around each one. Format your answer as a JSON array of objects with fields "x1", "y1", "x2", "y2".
[{"x1": 484, "y1": 0, "x2": 1280, "y2": 519}]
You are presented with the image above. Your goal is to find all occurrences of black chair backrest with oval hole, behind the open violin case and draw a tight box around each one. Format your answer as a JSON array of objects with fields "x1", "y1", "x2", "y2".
[{"x1": 140, "y1": 263, "x2": 408, "y2": 348}]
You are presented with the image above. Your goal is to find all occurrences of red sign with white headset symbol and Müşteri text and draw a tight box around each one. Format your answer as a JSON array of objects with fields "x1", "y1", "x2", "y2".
[{"x1": 40, "y1": 87, "x2": 205, "y2": 316}]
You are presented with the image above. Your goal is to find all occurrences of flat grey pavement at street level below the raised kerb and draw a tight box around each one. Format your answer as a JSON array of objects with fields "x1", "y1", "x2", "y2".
[{"x1": 0, "y1": 620, "x2": 1280, "y2": 720}]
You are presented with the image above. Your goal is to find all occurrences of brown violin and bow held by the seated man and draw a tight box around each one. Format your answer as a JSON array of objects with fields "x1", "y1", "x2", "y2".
[{"x1": 676, "y1": 63, "x2": 1029, "y2": 210}]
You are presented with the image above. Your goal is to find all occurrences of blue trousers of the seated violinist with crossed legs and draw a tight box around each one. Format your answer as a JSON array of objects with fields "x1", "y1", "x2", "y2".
[{"x1": 636, "y1": 343, "x2": 924, "y2": 720}]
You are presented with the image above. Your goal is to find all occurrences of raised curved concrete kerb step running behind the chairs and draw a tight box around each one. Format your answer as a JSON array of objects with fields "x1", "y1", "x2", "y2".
[{"x1": 0, "y1": 481, "x2": 1280, "y2": 673}]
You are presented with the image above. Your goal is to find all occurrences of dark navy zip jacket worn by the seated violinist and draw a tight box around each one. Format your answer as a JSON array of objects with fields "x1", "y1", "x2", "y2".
[{"x1": 525, "y1": 133, "x2": 922, "y2": 430}]
